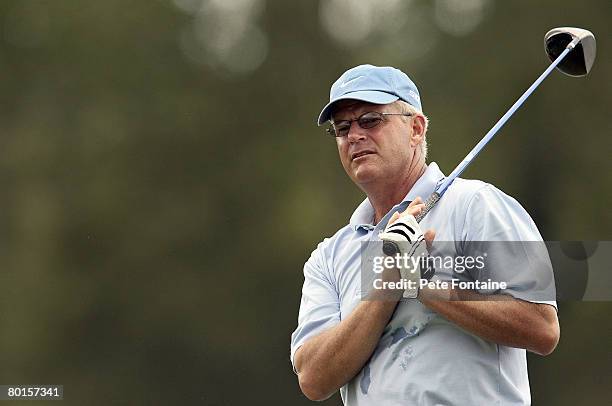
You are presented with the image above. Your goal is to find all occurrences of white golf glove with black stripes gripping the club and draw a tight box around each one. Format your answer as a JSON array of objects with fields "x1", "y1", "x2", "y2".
[{"x1": 379, "y1": 214, "x2": 433, "y2": 299}]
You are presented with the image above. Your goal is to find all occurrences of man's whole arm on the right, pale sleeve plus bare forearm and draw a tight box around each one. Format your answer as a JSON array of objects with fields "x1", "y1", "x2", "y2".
[{"x1": 420, "y1": 185, "x2": 559, "y2": 355}]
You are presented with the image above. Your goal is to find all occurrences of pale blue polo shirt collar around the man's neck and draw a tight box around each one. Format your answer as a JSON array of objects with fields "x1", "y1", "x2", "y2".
[{"x1": 350, "y1": 162, "x2": 444, "y2": 231}]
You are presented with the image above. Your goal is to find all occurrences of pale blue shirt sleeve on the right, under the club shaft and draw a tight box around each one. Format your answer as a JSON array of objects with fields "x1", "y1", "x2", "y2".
[{"x1": 462, "y1": 185, "x2": 557, "y2": 308}]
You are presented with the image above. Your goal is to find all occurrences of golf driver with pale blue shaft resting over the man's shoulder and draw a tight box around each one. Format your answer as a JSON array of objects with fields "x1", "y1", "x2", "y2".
[{"x1": 414, "y1": 27, "x2": 596, "y2": 224}]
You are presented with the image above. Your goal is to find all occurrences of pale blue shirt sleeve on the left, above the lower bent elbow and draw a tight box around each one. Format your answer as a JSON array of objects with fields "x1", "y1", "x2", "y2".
[{"x1": 291, "y1": 243, "x2": 340, "y2": 372}]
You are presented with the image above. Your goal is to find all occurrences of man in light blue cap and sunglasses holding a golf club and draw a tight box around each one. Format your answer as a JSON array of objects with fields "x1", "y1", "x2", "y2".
[{"x1": 291, "y1": 65, "x2": 559, "y2": 406}]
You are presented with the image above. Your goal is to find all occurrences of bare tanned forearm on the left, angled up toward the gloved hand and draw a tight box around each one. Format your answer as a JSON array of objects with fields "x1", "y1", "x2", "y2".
[{"x1": 295, "y1": 294, "x2": 397, "y2": 400}]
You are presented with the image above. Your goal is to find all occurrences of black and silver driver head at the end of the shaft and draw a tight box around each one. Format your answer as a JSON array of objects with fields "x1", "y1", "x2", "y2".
[{"x1": 544, "y1": 27, "x2": 596, "y2": 76}]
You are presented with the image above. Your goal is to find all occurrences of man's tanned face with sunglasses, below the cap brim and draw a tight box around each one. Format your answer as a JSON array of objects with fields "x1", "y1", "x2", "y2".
[{"x1": 333, "y1": 101, "x2": 424, "y2": 190}]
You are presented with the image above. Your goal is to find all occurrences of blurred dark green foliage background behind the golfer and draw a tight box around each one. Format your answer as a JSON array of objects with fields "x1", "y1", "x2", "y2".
[{"x1": 0, "y1": 0, "x2": 612, "y2": 405}]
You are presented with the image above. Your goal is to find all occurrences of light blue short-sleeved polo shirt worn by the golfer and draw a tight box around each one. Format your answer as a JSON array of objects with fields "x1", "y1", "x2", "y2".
[{"x1": 291, "y1": 163, "x2": 556, "y2": 406}]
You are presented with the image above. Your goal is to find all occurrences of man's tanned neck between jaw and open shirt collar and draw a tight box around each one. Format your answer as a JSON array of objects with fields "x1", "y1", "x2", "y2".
[{"x1": 362, "y1": 161, "x2": 427, "y2": 224}]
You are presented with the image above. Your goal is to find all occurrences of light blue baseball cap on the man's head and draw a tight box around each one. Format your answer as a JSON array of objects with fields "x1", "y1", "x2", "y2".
[{"x1": 318, "y1": 65, "x2": 423, "y2": 125}]
